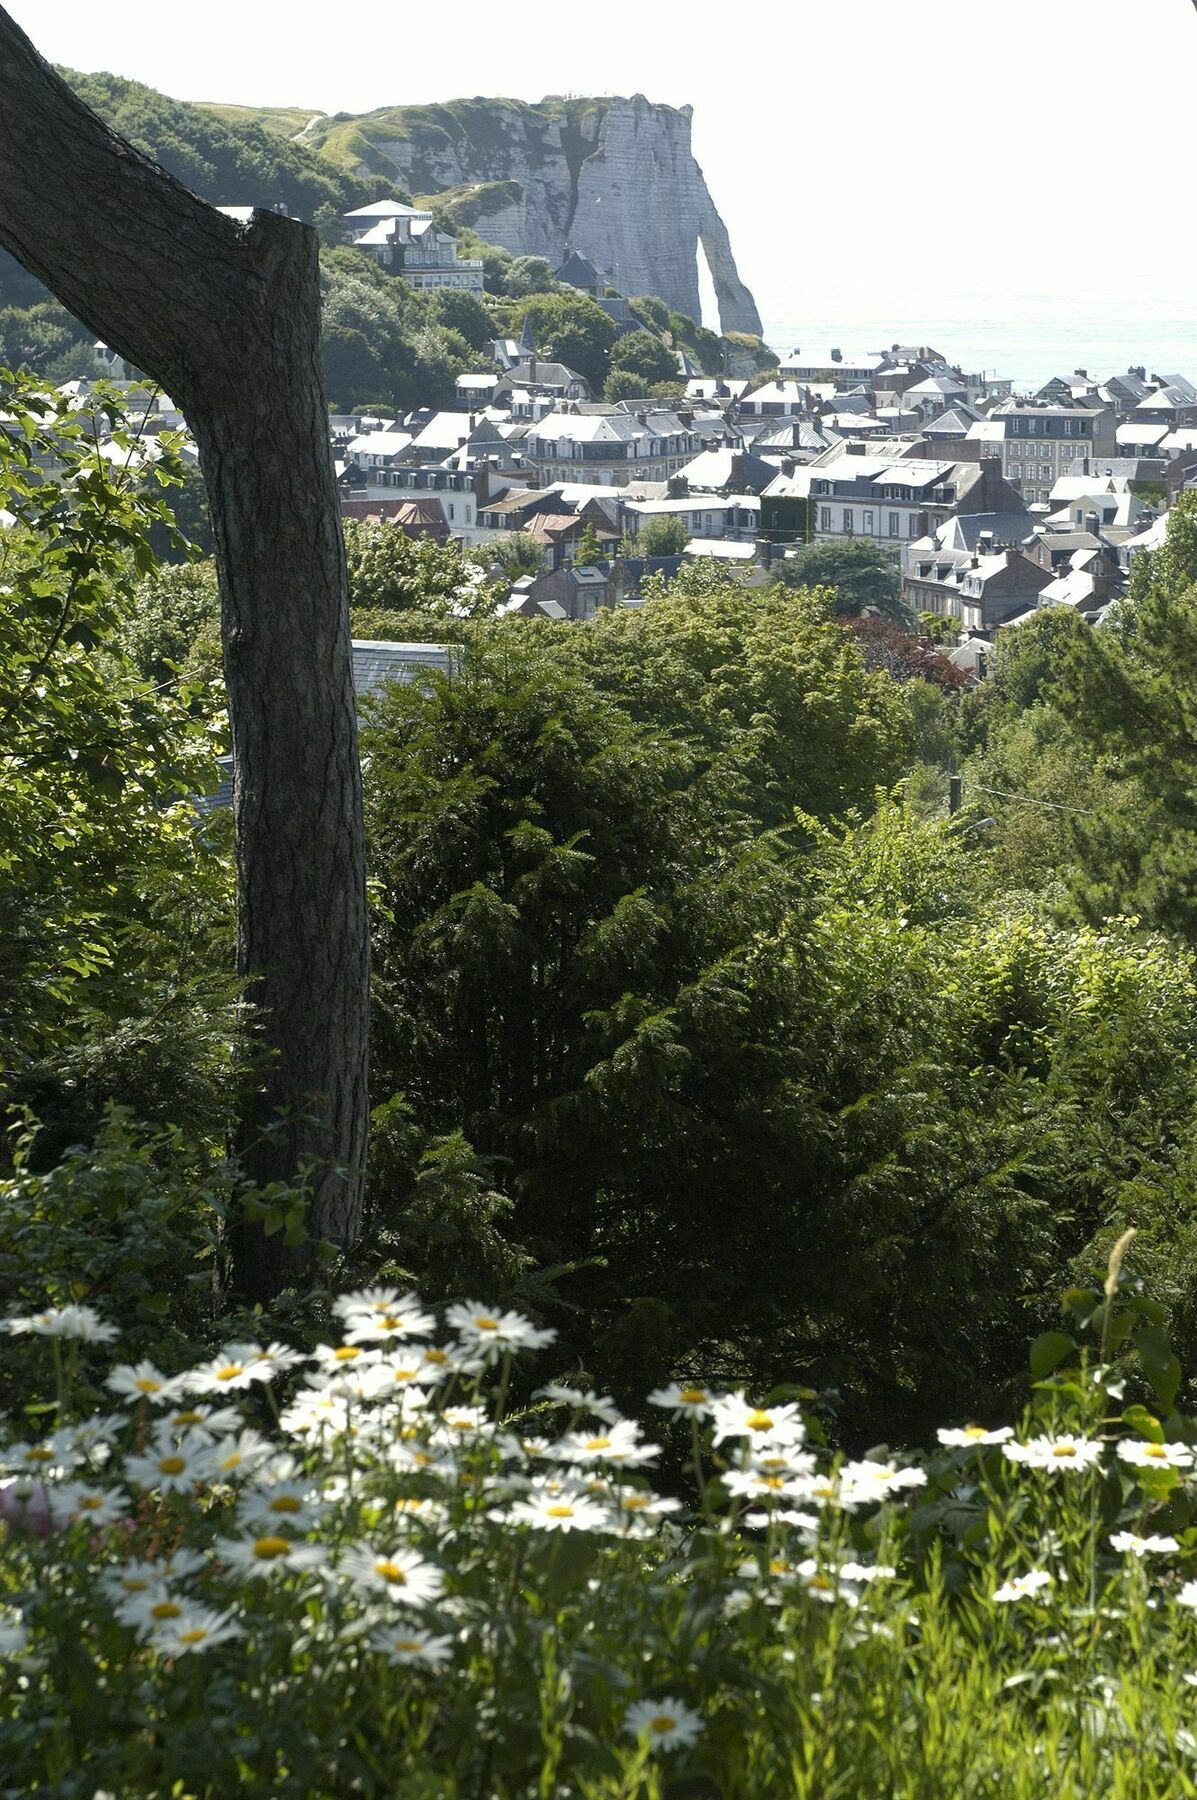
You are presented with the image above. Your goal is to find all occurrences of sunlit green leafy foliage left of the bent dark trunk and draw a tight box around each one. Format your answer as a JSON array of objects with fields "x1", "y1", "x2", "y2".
[{"x1": 0, "y1": 378, "x2": 232, "y2": 1154}]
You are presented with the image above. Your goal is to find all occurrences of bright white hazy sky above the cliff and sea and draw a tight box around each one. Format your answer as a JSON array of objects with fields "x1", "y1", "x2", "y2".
[{"x1": 7, "y1": 0, "x2": 1197, "y2": 361}]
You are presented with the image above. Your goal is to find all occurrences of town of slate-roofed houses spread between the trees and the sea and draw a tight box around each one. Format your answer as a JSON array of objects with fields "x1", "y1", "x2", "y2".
[{"x1": 70, "y1": 200, "x2": 1197, "y2": 680}]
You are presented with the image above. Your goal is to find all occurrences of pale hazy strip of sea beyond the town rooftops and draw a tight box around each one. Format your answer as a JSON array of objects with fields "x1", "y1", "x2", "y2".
[{"x1": 758, "y1": 290, "x2": 1197, "y2": 392}]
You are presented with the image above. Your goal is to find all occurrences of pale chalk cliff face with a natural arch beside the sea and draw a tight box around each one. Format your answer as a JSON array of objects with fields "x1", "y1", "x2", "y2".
[{"x1": 345, "y1": 94, "x2": 761, "y2": 335}]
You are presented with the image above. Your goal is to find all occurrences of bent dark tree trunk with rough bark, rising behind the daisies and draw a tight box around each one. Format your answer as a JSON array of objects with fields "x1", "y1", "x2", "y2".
[{"x1": 0, "y1": 7, "x2": 369, "y2": 1300}]
